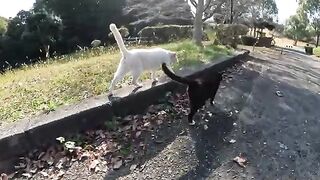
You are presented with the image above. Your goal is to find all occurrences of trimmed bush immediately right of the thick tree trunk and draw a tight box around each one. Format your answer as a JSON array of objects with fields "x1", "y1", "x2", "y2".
[{"x1": 208, "y1": 24, "x2": 249, "y2": 47}]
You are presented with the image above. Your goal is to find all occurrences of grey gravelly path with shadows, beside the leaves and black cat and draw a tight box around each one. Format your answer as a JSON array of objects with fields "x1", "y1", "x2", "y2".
[{"x1": 11, "y1": 48, "x2": 320, "y2": 180}]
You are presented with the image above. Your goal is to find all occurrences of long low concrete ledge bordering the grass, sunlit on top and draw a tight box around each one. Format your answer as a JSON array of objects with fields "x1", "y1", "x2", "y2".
[{"x1": 0, "y1": 51, "x2": 249, "y2": 172}]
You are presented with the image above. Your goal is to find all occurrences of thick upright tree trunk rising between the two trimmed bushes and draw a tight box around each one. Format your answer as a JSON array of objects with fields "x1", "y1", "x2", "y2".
[{"x1": 193, "y1": 0, "x2": 204, "y2": 46}]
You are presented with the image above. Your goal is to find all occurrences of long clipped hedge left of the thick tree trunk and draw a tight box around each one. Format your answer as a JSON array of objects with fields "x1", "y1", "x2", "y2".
[{"x1": 138, "y1": 25, "x2": 193, "y2": 43}]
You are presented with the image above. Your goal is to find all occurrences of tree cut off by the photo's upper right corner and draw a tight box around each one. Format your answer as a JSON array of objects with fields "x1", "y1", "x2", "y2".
[{"x1": 299, "y1": 0, "x2": 320, "y2": 47}]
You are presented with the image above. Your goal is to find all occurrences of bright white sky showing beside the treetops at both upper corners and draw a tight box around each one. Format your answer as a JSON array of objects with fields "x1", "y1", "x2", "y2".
[{"x1": 0, "y1": 0, "x2": 298, "y2": 23}]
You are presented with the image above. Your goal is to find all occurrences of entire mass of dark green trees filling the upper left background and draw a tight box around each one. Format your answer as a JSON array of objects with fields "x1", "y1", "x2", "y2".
[{"x1": 0, "y1": 0, "x2": 125, "y2": 71}]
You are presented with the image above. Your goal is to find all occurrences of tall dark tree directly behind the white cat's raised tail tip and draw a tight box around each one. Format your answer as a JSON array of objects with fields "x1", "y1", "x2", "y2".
[{"x1": 35, "y1": 0, "x2": 125, "y2": 48}]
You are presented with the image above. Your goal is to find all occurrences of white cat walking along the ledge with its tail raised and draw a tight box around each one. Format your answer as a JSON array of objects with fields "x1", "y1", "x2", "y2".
[{"x1": 109, "y1": 24, "x2": 177, "y2": 92}]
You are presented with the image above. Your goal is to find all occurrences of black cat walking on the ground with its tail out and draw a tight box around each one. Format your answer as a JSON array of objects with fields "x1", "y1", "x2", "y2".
[{"x1": 162, "y1": 63, "x2": 222, "y2": 125}]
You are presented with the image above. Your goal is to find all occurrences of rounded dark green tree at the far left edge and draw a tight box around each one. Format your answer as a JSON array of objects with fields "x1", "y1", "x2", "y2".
[{"x1": 0, "y1": 11, "x2": 62, "y2": 66}]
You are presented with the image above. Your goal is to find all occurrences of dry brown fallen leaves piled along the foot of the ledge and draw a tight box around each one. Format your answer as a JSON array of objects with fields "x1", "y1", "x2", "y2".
[{"x1": 9, "y1": 94, "x2": 188, "y2": 180}]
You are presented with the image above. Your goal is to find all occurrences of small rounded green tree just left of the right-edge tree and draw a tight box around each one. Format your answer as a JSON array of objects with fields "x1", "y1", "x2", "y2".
[{"x1": 285, "y1": 8, "x2": 309, "y2": 46}]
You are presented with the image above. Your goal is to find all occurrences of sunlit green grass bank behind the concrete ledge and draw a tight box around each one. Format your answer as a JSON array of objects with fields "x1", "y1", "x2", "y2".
[{"x1": 0, "y1": 41, "x2": 230, "y2": 124}]
